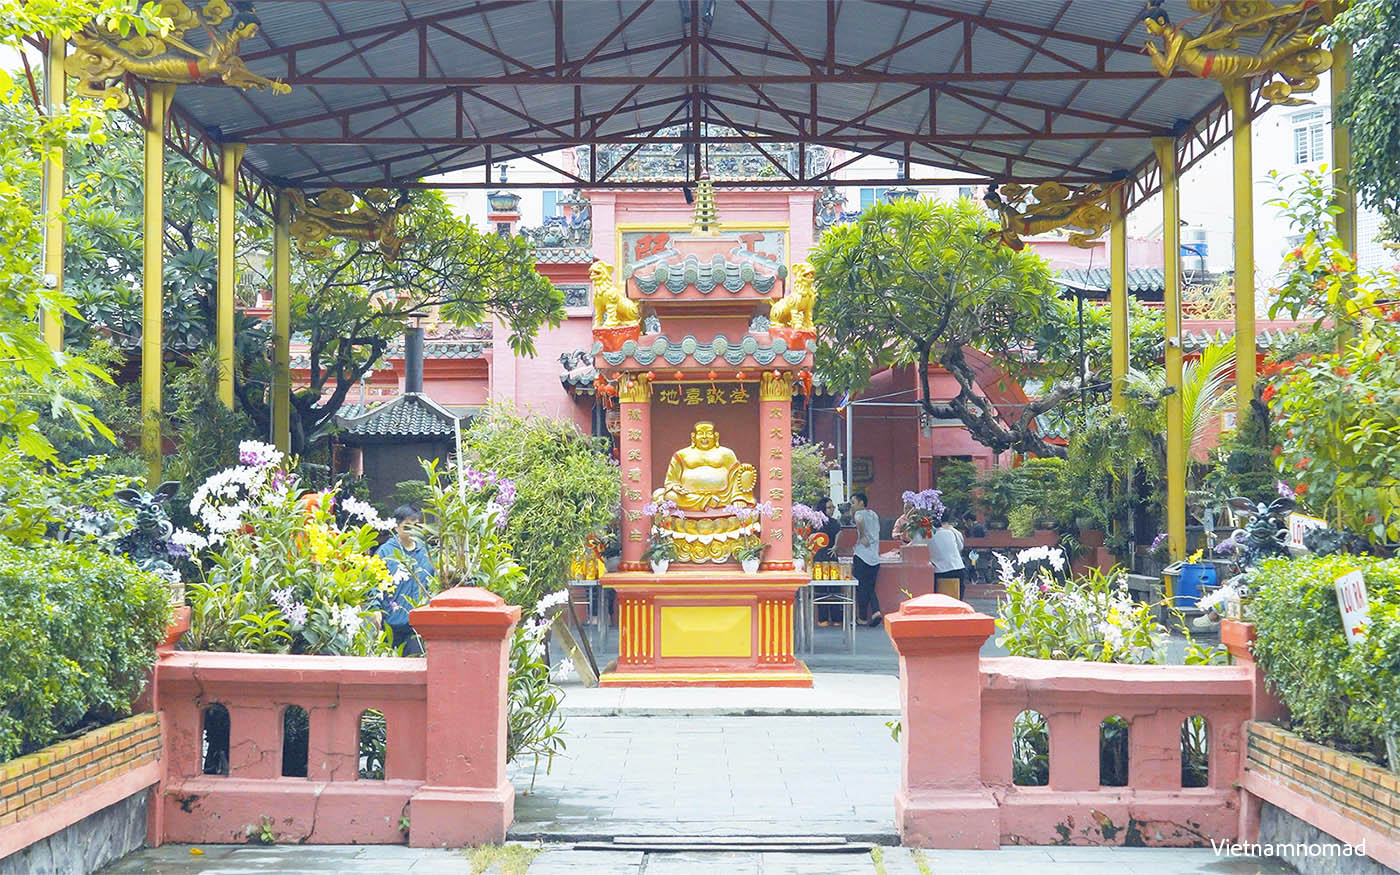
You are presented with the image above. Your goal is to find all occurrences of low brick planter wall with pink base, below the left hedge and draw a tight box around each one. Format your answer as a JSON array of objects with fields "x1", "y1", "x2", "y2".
[{"x1": 0, "y1": 714, "x2": 161, "y2": 857}]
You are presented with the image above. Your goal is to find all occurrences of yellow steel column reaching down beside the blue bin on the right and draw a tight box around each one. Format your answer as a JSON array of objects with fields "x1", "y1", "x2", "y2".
[{"x1": 1152, "y1": 137, "x2": 1186, "y2": 560}]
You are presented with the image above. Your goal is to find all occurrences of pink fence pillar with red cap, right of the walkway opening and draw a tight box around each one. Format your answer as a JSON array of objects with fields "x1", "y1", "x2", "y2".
[{"x1": 885, "y1": 594, "x2": 1001, "y2": 848}]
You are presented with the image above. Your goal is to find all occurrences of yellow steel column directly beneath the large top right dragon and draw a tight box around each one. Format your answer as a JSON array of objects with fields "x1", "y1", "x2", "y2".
[{"x1": 1225, "y1": 81, "x2": 1257, "y2": 409}]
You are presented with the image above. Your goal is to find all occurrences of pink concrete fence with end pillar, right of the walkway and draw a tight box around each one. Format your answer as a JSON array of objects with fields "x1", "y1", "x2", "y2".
[{"x1": 885, "y1": 595, "x2": 1257, "y2": 848}]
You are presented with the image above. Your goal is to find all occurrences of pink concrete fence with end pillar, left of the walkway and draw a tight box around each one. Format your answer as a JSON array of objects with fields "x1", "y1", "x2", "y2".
[{"x1": 148, "y1": 588, "x2": 519, "y2": 847}]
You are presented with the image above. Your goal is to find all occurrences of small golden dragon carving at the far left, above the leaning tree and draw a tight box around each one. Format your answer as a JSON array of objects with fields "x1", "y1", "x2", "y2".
[{"x1": 287, "y1": 189, "x2": 409, "y2": 262}]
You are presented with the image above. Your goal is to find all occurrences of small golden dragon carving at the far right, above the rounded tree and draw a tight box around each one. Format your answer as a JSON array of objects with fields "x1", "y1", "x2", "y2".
[{"x1": 983, "y1": 182, "x2": 1113, "y2": 252}]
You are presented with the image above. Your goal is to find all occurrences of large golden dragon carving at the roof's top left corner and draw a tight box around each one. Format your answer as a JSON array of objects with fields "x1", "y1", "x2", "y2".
[{"x1": 67, "y1": 0, "x2": 291, "y2": 108}]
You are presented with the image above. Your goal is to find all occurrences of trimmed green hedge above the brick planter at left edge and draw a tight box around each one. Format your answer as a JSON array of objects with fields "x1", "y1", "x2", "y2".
[{"x1": 0, "y1": 538, "x2": 169, "y2": 760}]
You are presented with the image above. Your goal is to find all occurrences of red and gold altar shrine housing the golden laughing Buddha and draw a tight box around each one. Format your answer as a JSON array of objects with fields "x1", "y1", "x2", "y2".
[{"x1": 592, "y1": 179, "x2": 815, "y2": 686}]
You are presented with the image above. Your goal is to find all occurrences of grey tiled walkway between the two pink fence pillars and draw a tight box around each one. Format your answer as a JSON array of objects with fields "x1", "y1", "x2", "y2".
[{"x1": 510, "y1": 717, "x2": 899, "y2": 843}]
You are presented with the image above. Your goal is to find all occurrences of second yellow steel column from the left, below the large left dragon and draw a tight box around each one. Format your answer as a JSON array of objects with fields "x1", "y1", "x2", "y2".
[{"x1": 141, "y1": 84, "x2": 175, "y2": 484}]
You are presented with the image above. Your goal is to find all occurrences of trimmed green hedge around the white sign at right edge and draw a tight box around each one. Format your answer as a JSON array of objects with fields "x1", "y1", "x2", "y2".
[{"x1": 1249, "y1": 556, "x2": 1400, "y2": 759}]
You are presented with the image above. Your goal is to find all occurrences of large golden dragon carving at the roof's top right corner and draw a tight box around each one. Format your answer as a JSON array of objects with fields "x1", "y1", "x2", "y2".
[{"x1": 1144, "y1": 0, "x2": 1337, "y2": 106}]
